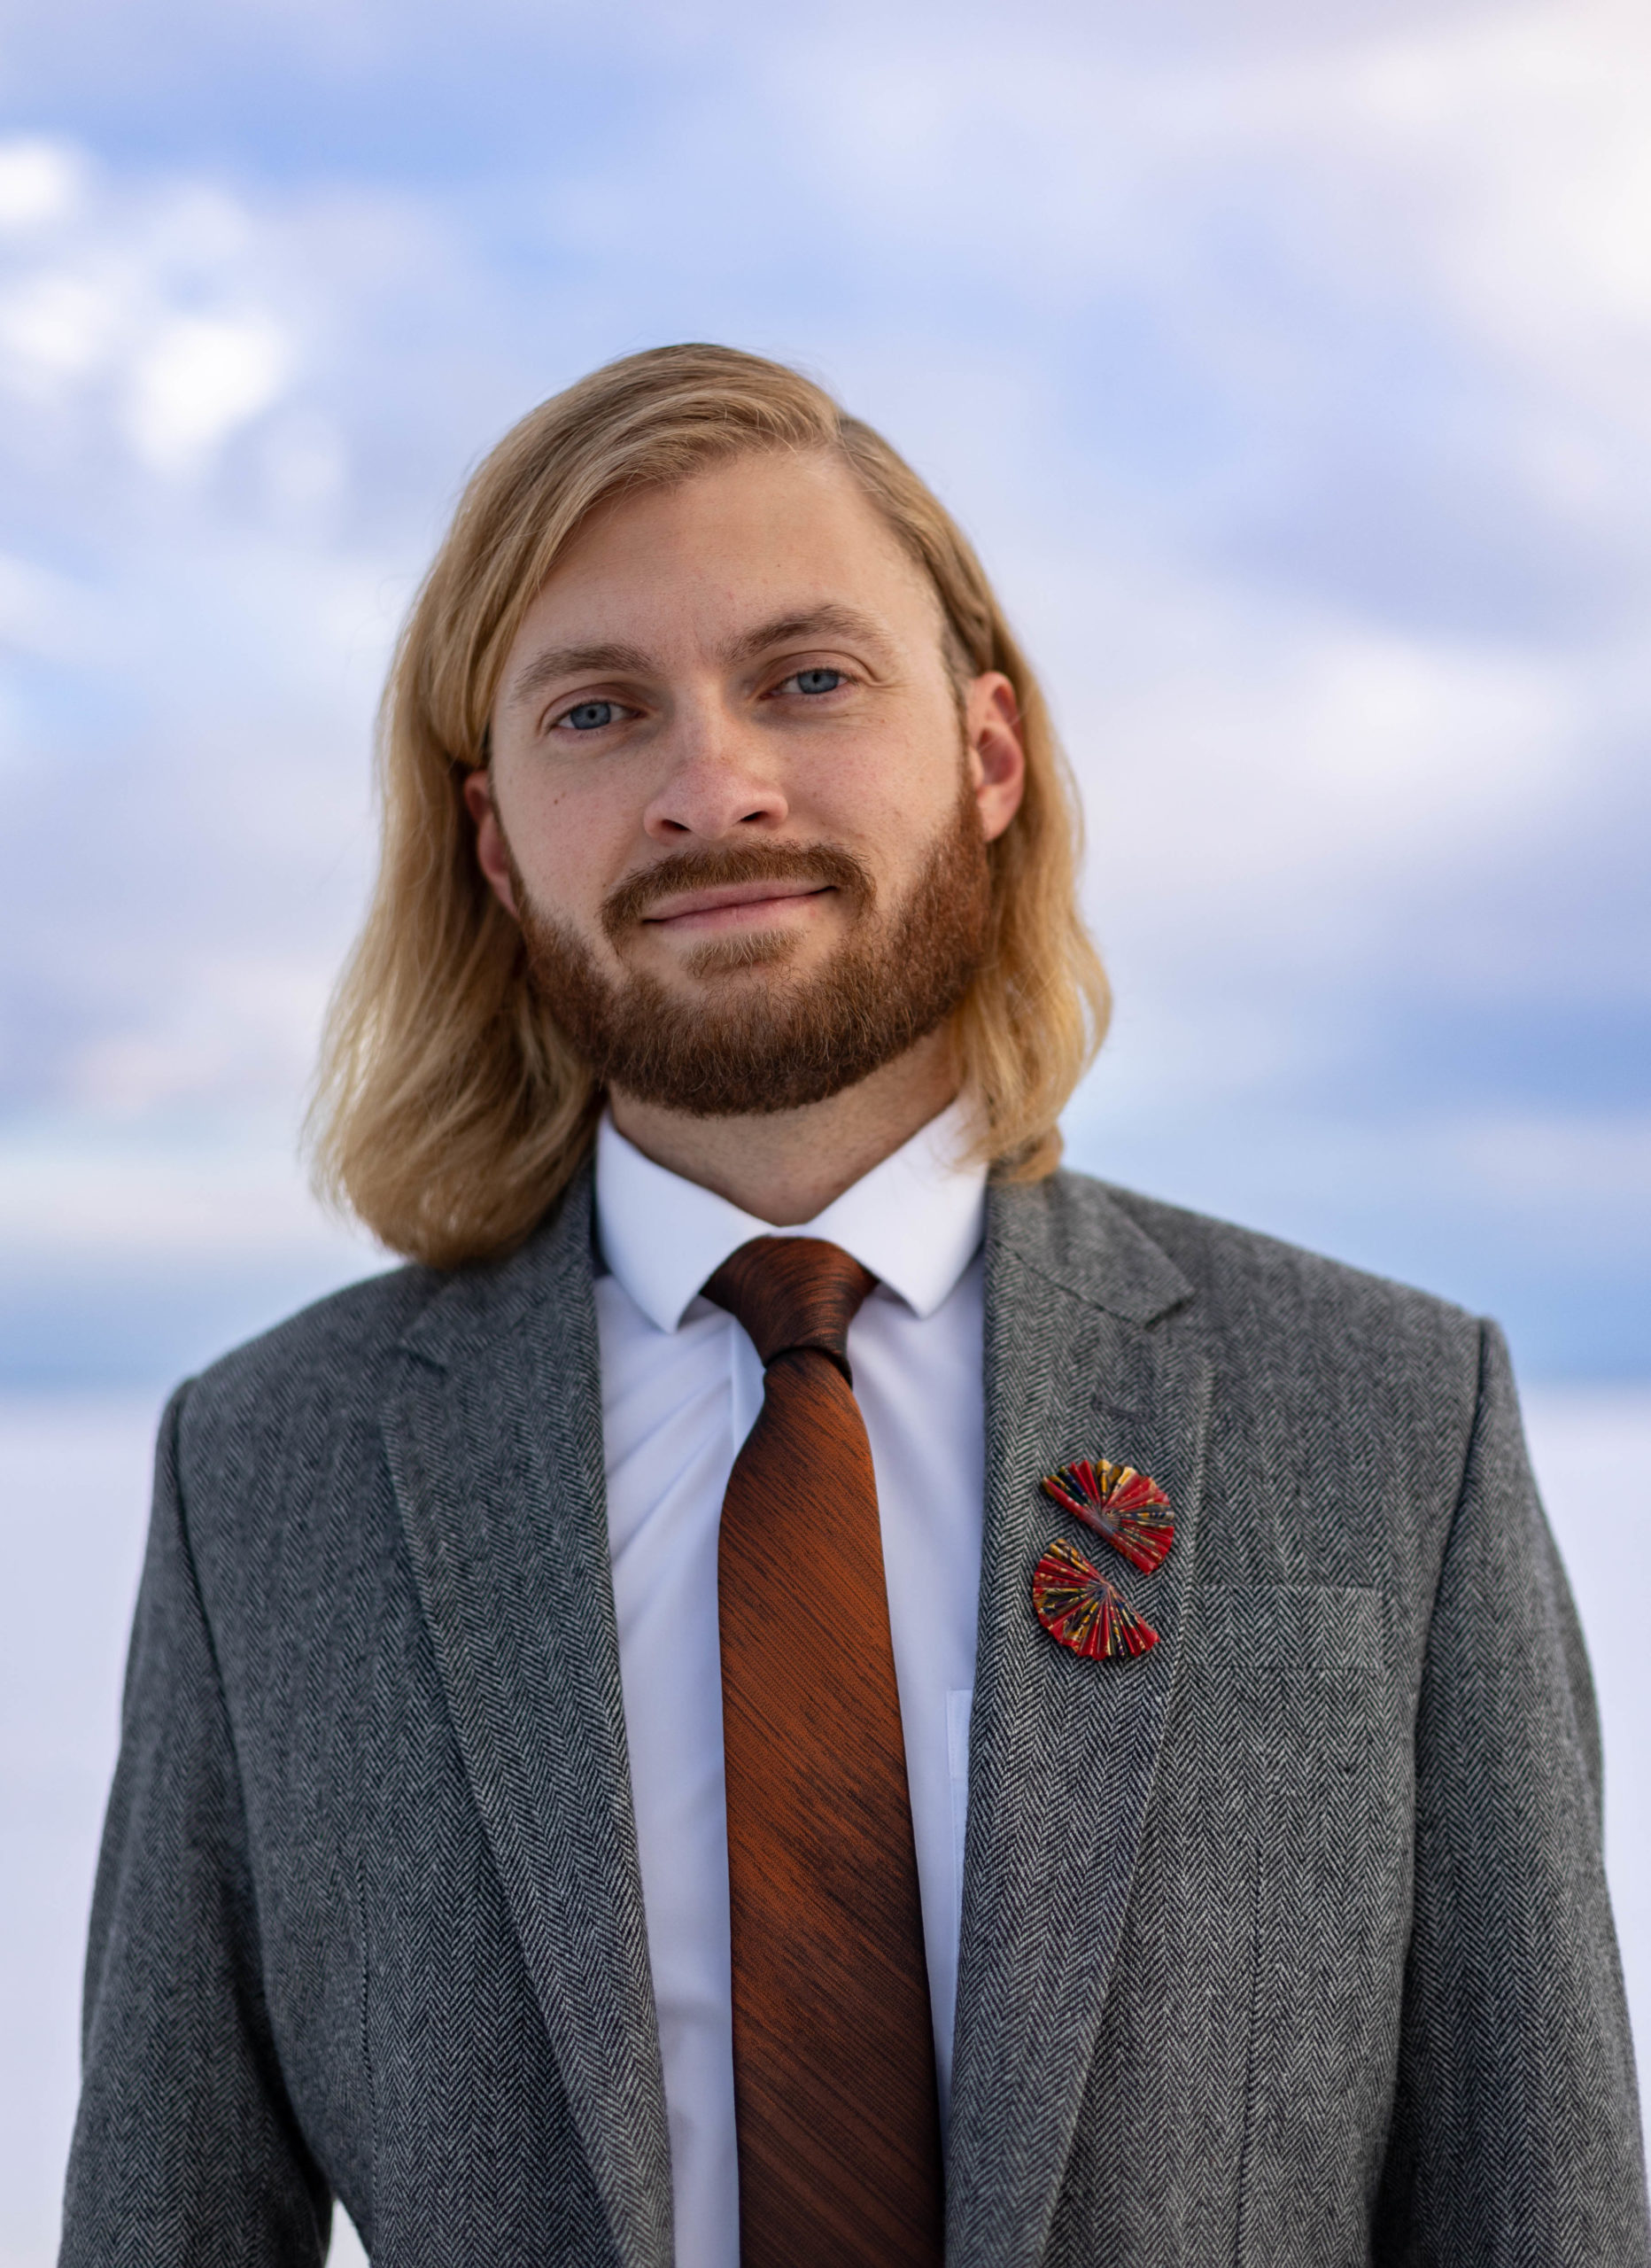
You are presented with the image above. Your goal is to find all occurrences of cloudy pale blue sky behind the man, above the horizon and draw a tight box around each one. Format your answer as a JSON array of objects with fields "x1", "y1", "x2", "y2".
[{"x1": 0, "y1": 0, "x2": 1651, "y2": 1386}]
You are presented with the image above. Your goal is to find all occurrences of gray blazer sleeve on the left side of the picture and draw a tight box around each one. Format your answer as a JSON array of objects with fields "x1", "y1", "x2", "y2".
[{"x1": 61, "y1": 1390, "x2": 331, "y2": 2268}]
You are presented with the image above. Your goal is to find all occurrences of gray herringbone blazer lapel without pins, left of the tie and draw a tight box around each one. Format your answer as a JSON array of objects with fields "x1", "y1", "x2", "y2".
[{"x1": 384, "y1": 1175, "x2": 671, "y2": 2268}]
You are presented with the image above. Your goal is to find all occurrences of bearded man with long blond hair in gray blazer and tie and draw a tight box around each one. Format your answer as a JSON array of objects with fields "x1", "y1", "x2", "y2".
[{"x1": 64, "y1": 347, "x2": 1647, "y2": 2268}]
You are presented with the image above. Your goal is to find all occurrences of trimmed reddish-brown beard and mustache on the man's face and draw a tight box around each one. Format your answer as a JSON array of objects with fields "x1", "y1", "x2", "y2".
[{"x1": 515, "y1": 791, "x2": 991, "y2": 1118}]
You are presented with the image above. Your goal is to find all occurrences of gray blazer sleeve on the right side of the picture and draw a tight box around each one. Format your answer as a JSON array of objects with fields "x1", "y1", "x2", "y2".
[{"x1": 1375, "y1": 1324, "x2": 1651, "y2": 2268}]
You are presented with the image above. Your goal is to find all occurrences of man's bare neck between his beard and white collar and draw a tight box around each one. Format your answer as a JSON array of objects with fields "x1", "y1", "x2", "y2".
[{"x1": 608, "y1": 1032, "x2": 957, "y2": 1230}]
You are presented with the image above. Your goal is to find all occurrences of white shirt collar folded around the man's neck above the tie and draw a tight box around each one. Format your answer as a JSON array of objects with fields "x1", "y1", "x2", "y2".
[{"x1": 596, "y1": 1102, "x2": 987, "y2": 1332}]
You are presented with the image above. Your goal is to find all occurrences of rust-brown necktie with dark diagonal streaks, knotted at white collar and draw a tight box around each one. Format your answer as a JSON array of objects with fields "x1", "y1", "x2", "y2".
[{"x1": 705, "y1": 1236, "x2": 943, "y2": 2268}]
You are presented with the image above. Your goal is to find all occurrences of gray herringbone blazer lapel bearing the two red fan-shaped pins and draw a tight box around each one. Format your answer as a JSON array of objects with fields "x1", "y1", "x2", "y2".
[{"x1": 946, "y1": 1175, "x2": 1209, "y2": 2268}]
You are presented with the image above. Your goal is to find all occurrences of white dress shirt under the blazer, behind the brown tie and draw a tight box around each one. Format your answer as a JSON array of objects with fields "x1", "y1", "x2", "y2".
[{"x1": 596, "y1": 1109, "x2": 987, "y2": 2268}]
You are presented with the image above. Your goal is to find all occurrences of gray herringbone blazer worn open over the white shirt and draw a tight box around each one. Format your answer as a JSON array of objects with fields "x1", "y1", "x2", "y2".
[{"x1": 64, "y1": 1175, "x2": 1648, "y2": 2268}]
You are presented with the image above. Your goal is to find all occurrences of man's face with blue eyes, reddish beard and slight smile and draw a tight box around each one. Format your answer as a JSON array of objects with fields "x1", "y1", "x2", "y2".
[{"x1": 467, "y1": 454, "x2": 1023, "y2": 1111}]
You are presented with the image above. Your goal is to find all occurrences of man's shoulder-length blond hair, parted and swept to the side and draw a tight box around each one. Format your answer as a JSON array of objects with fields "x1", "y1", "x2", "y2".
[{"x1": 311, "y1": 345, "x2": 1109, "y2": 1268}]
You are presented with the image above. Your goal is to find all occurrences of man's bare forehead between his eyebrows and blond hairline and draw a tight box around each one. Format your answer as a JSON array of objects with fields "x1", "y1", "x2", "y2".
[{"x1": 513, "y1": 451, "x2": 942, "y2": 657}]
